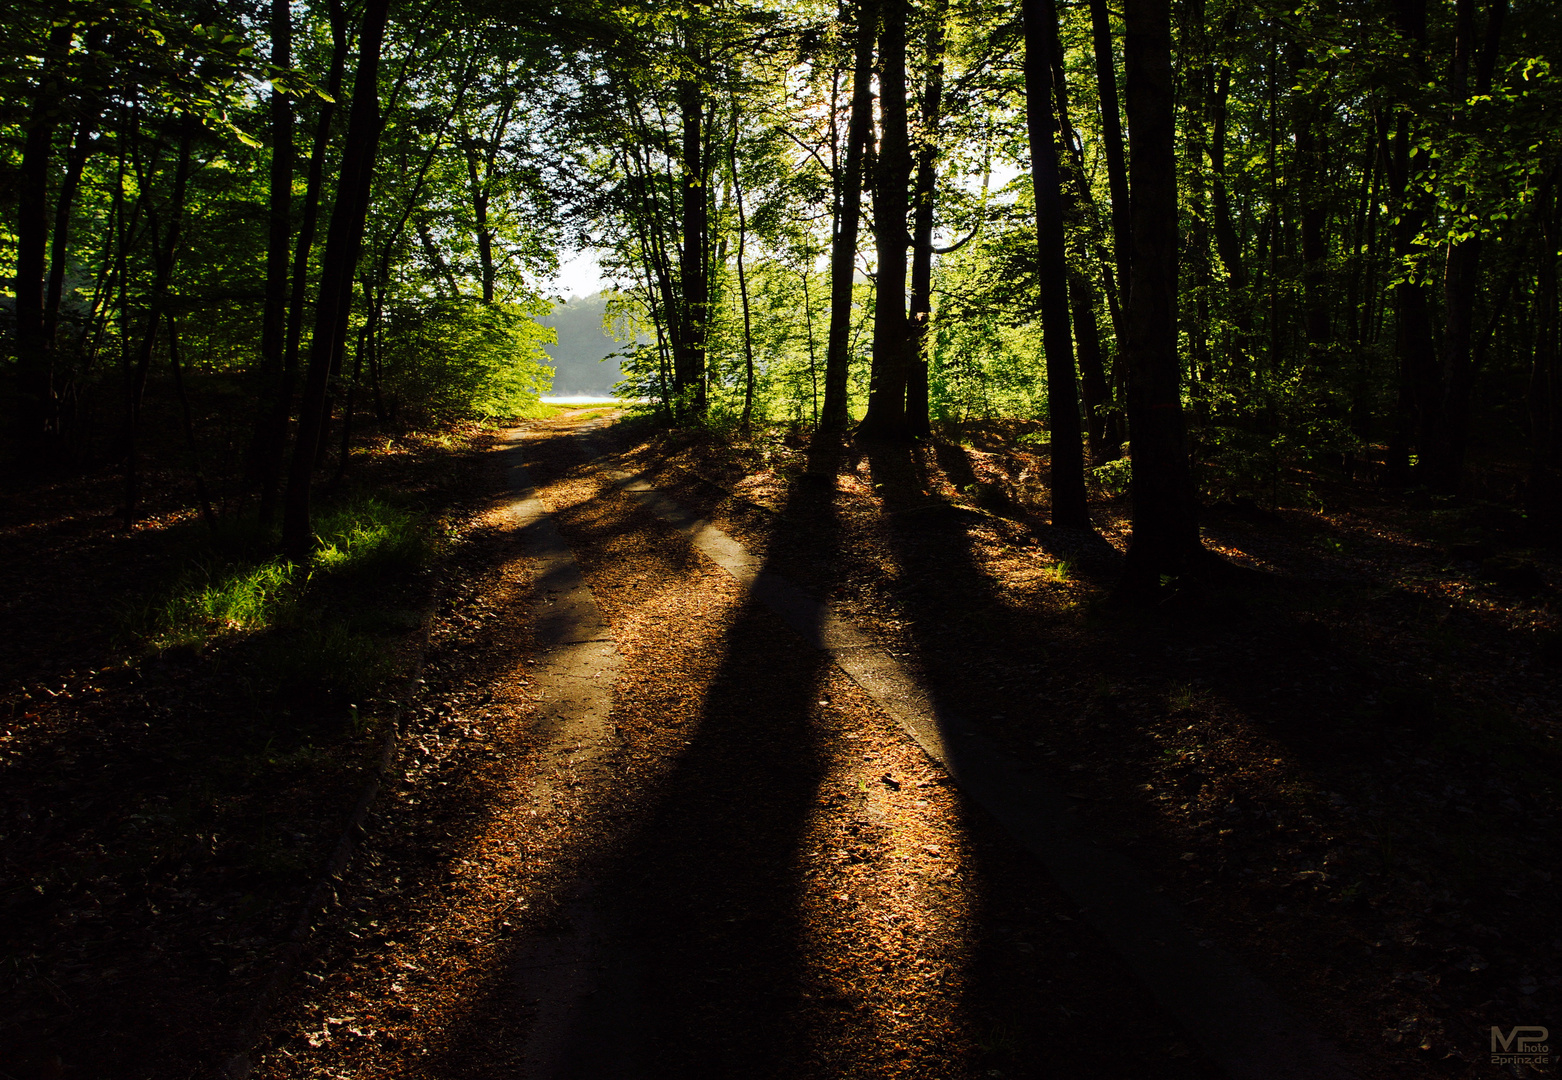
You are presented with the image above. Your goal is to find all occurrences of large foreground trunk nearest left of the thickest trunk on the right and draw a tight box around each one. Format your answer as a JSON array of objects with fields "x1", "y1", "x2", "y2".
[{"x1": 1020, "y1": 0, "x2": 1090, "y2": 528}]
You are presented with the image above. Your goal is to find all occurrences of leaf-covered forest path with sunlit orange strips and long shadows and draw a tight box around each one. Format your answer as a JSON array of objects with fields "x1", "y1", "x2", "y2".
[{"x1": 256, "y1": 417, "x2": 1329, "y2": 1077}]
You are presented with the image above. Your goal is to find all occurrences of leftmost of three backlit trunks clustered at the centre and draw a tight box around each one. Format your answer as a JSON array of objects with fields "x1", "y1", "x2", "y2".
[{"x1": 818, "y1": 0, "x2": 878, "y2": 433}]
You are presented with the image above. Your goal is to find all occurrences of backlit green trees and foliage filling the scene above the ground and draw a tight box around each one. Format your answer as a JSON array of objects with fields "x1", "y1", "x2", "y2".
[{"x1": 0, "y1": 0, "x2": 1562, "y2": 578}]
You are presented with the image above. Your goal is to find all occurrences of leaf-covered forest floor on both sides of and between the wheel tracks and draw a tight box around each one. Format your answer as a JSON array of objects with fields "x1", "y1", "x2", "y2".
[{"x1": 0, "y1": 414, "x2": 1562, "y2": 1080}]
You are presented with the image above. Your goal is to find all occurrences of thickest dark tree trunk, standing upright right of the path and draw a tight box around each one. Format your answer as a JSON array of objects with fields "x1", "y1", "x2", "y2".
[{"x1": 1125, "y1": 0, "x2": 1204, "y2": 589}]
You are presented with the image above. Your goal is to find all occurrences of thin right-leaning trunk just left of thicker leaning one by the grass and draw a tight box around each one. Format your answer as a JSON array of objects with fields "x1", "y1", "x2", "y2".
[{"x1": 255, "y1": 0, "x2": 347, "y2": 527}]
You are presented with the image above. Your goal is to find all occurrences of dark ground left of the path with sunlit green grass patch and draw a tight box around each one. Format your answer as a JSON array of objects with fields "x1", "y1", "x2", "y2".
[{"x1": 0, "y1": 424, "x2": 490, "y2": 1075}]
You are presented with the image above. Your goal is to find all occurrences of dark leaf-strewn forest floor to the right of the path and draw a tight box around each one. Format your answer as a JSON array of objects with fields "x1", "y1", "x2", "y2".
[{"x1": 637, "y1": 424, "x2": 1562, "y2": 1077}]
